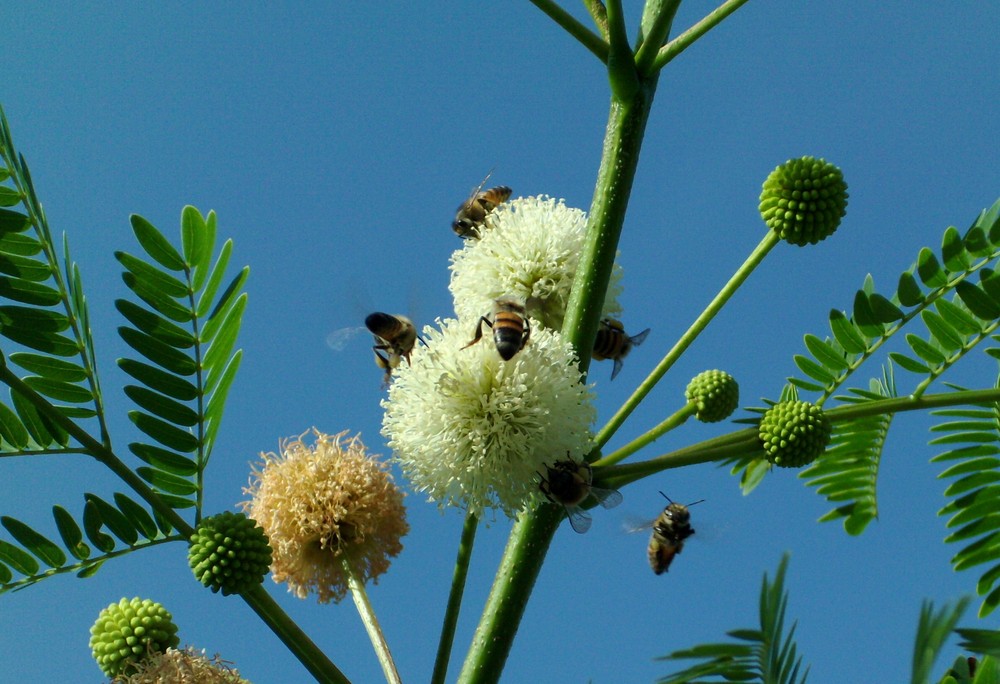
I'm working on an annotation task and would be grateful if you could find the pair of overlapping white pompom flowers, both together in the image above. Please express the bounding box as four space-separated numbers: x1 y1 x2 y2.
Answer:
382 197 621 517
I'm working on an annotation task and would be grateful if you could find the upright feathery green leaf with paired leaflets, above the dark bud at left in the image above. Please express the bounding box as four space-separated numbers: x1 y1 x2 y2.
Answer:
116 207 247 512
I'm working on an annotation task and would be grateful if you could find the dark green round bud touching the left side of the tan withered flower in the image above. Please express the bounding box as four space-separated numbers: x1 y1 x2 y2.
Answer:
188 511 271 596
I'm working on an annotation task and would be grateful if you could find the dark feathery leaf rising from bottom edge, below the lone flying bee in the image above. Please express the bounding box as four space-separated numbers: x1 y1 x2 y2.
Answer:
659 554 808 684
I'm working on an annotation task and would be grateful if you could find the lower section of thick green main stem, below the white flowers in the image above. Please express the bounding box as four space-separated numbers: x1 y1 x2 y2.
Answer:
458 505 565 684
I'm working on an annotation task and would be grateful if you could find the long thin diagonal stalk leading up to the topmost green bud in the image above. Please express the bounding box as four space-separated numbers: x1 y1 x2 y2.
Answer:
594 230 780 448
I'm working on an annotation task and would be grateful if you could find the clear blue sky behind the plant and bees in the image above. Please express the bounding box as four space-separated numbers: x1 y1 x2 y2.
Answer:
0 0 1000 684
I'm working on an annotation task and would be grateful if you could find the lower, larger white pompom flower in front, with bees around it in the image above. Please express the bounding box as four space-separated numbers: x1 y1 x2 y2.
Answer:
382 319 596 517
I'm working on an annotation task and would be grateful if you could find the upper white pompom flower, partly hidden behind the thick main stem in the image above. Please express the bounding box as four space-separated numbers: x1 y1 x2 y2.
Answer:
449 195 622 330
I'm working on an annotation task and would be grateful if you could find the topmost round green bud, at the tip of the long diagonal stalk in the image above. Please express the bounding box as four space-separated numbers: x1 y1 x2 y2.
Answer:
760 157 847 247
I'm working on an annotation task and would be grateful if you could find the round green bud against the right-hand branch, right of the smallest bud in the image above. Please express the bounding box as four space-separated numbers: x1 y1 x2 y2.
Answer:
757 401 833 468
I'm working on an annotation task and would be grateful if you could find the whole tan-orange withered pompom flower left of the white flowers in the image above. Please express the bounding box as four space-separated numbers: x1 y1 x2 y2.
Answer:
243 430 410 603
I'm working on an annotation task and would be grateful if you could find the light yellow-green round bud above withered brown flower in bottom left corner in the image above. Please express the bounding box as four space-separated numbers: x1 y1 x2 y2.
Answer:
90 597 180 677
